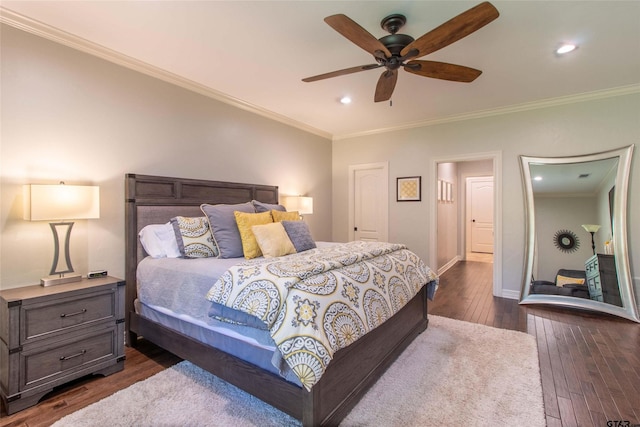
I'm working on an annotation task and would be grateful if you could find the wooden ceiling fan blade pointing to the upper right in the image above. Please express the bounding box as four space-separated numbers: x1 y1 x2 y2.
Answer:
400 2 500 58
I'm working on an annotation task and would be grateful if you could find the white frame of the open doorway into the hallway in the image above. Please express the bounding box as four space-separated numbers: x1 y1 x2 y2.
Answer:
427 151 504 298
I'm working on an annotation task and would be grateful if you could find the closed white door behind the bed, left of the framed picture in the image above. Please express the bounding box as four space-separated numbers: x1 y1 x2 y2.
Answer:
349 163 389 241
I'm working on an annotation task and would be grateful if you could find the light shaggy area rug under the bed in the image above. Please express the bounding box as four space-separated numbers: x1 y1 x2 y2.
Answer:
54 316 546 427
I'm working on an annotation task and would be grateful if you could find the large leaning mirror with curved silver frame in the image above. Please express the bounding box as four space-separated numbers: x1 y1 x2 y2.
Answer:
520 145 640 322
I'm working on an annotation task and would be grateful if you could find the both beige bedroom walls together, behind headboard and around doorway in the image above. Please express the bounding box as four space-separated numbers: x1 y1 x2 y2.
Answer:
0 22 640 310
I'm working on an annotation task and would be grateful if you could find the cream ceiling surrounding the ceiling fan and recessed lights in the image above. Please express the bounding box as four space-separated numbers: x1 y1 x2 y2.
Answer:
1 0 640 139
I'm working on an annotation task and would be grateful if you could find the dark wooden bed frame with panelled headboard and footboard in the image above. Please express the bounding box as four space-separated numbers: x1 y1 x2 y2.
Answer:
125 174 428 426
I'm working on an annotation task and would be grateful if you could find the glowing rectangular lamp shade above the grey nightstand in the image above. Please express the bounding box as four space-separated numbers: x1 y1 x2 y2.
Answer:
23 184 100 221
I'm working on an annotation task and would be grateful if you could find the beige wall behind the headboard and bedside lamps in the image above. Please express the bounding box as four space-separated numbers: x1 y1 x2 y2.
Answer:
0 26 331 289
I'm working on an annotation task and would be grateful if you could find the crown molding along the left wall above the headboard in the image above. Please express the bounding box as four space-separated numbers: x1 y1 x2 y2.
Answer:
0 6 332 140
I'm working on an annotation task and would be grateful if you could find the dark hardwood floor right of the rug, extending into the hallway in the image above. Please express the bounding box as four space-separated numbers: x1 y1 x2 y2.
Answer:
429 262 640 427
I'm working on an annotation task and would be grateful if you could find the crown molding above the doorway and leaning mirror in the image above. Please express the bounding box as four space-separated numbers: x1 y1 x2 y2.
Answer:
333 84 640 141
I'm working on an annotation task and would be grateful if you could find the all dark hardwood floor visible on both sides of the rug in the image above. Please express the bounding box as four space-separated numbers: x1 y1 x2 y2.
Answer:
0 262 640 427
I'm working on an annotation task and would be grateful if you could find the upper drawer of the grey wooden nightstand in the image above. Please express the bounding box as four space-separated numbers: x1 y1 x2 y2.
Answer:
20 287 116 345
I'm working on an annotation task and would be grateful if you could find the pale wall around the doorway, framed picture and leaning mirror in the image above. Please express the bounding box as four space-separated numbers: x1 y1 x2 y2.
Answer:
332 94 640 306
